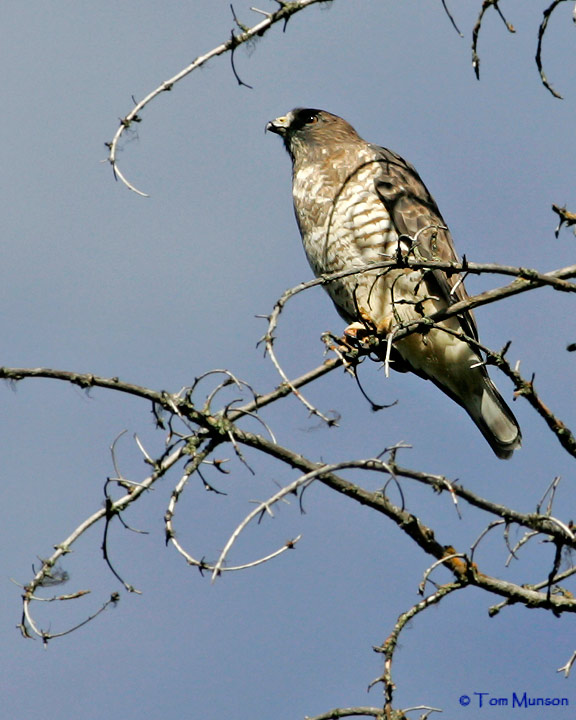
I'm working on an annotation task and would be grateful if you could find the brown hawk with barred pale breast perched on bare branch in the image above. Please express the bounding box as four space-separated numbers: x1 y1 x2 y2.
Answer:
266 108 522 459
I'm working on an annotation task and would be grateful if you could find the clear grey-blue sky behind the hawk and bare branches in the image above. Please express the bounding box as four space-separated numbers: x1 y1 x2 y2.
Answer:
0 0 576 720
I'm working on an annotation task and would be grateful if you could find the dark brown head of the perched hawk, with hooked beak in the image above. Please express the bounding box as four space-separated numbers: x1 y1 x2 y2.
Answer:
266 108 359 159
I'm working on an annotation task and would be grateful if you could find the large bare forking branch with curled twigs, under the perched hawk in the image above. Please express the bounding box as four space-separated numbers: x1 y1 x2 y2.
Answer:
6 253 576 718
